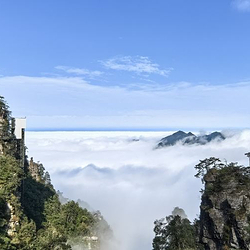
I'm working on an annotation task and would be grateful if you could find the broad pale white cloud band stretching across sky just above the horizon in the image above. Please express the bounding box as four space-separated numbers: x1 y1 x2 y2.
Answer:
0 76 250 129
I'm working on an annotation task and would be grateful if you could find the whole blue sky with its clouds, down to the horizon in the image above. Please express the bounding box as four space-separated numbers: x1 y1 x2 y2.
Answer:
0 0 250 129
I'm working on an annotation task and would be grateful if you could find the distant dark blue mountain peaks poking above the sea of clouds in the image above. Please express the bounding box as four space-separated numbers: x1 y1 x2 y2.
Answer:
157 131 226 148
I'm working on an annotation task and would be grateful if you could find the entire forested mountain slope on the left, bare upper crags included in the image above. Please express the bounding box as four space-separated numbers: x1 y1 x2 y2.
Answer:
0 97 112 250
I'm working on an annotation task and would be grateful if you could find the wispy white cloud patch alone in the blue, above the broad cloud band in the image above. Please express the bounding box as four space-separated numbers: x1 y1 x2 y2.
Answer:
102 56 173 77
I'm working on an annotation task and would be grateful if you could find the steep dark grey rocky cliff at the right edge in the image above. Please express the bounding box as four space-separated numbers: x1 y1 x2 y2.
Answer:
200 164 250 250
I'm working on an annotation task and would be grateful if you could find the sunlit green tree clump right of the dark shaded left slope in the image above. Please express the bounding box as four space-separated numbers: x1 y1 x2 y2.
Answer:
35 195 95 249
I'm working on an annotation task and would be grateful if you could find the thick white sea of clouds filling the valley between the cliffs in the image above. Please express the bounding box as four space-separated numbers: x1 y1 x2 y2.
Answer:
26 130 250 250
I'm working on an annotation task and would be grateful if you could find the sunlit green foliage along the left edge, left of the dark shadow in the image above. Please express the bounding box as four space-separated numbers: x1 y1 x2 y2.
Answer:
0 155 36 249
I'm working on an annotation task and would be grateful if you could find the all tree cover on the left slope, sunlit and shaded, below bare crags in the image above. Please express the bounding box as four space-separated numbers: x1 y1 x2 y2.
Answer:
0 155 104 250
